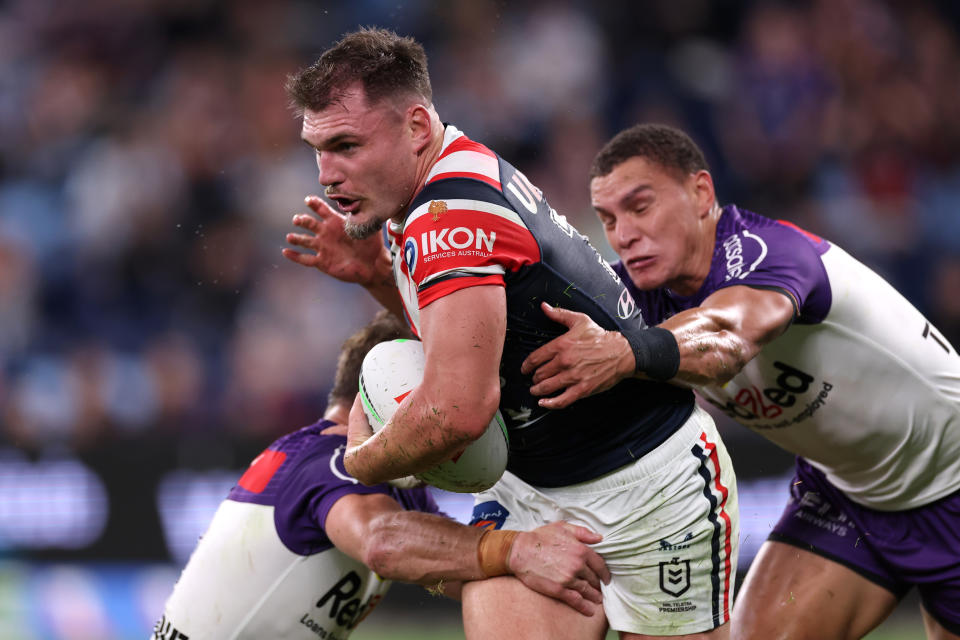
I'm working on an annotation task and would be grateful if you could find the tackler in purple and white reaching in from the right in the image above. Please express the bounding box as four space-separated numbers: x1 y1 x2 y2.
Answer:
524 125 960 640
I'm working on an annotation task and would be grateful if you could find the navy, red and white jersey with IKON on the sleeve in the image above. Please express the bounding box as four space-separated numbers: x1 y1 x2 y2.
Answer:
388 125 694 487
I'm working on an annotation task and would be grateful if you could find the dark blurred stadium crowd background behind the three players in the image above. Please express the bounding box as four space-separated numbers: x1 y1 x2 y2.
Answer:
0 0 960 640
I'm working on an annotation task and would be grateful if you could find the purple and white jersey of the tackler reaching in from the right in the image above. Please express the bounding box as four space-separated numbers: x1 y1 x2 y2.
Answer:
614 206 960 511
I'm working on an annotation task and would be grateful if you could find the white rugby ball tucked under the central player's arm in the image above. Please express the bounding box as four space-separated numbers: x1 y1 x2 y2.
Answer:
360 339 507 493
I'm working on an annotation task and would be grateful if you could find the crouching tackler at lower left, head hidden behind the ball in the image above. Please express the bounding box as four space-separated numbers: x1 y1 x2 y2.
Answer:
153 311 609 640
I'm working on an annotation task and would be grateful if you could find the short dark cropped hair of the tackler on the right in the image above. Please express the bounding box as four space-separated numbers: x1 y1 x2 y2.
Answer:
590 124 710 180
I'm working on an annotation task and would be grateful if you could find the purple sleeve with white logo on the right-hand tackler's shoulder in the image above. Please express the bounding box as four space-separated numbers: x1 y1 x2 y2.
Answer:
710 221 831 324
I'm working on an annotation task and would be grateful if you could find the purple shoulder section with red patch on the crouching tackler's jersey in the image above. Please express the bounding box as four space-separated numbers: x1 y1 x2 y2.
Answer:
228 420 439 555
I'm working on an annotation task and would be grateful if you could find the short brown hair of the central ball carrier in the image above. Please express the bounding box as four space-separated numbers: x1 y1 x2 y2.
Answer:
286 28 433 113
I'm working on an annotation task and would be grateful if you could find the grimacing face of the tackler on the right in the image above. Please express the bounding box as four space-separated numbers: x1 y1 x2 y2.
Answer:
590 156 714 295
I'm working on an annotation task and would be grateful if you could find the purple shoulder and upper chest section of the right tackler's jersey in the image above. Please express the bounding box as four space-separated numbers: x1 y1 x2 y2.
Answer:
613 205 831 325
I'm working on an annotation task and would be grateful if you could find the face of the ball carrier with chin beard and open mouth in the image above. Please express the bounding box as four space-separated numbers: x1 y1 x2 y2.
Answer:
301 88 417 238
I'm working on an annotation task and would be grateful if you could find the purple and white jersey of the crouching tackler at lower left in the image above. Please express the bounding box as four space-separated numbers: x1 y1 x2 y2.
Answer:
153 421 439 640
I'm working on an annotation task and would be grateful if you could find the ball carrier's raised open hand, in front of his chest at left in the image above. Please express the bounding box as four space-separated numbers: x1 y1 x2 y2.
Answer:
283 196 390 286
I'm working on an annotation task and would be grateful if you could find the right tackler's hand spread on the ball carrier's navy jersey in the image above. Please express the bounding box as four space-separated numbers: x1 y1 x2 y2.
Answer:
520 302 636 409
